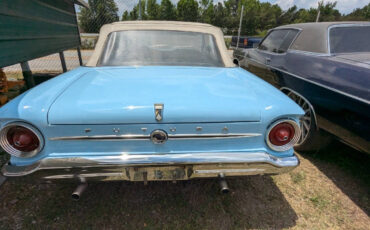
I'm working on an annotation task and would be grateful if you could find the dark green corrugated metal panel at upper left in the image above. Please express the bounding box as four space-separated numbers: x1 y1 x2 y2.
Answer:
0 0 80 67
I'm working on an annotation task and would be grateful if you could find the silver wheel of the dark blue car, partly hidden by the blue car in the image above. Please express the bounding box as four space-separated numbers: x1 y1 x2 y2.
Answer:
288 92 312 145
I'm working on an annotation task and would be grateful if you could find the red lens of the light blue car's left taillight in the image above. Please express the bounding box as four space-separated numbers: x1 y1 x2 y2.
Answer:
6 126 40 152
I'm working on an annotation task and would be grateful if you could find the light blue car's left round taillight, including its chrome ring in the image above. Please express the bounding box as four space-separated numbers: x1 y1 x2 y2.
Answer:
0 122 43 157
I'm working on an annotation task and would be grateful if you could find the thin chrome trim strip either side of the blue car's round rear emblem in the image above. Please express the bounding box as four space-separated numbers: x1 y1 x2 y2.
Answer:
49 133 262 141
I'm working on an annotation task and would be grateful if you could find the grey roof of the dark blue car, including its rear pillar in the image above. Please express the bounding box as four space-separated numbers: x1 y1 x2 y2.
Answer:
274 21 370 53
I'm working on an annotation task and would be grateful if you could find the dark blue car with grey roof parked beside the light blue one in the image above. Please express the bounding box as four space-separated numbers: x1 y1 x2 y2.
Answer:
239 22 370 153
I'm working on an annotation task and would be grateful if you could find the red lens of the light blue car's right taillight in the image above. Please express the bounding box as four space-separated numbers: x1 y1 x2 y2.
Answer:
268 122 295 146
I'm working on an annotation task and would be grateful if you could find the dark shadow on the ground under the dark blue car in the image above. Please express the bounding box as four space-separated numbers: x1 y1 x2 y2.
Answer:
302 141 370 216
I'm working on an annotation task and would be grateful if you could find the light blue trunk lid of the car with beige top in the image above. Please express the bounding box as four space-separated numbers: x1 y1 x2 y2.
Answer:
48 67 261 125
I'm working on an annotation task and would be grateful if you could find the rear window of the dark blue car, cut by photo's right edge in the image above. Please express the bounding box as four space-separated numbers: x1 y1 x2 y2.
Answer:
329 26 370 53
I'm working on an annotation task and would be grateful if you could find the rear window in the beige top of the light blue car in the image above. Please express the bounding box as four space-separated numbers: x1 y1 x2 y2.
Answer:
98 30 224 67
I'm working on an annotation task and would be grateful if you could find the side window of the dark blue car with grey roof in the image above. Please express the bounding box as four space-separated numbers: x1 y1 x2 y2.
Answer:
259 29 298 53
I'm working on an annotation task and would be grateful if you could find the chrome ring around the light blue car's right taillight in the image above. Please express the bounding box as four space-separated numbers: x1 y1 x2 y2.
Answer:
265 119 301 152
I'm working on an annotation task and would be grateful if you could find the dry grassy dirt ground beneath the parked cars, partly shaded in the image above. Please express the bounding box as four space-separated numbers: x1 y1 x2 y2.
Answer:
0 143 370 229
